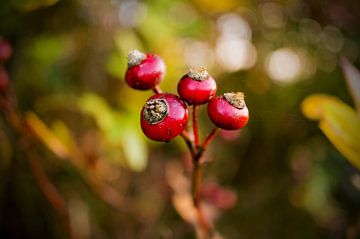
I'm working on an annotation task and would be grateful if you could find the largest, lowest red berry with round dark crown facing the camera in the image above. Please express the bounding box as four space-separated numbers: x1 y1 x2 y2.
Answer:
141 93 188 141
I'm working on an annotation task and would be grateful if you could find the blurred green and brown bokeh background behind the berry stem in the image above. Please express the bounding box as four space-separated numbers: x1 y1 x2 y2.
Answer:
0 0 360 239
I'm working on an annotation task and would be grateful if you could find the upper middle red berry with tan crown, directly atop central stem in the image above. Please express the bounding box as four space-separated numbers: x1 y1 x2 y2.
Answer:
178 67 217 105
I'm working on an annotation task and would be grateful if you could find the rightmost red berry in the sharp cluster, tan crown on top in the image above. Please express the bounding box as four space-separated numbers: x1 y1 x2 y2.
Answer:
207 92 249 130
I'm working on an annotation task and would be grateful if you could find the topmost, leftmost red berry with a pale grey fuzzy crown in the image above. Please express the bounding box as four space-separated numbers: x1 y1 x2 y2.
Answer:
125 50 165 90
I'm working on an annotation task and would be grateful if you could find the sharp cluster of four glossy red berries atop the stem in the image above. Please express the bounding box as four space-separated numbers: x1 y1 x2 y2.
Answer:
125 50 249 141
